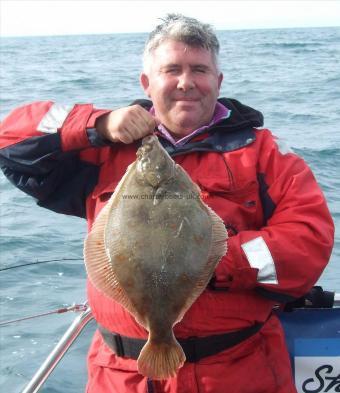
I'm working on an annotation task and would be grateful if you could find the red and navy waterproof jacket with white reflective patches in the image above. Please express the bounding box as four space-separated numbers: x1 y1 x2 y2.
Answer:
0 99 334 393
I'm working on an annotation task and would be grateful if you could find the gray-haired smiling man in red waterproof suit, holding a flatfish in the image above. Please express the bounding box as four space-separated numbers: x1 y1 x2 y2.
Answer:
0 15 334 393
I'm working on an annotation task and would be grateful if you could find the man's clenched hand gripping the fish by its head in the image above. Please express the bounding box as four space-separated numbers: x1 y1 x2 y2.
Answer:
96 105 159 144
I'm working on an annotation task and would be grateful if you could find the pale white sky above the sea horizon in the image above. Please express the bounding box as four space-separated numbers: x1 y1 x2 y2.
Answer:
0 0 340 37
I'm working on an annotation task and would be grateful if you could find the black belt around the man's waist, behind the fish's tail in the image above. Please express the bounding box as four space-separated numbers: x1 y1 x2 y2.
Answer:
98 323 263 363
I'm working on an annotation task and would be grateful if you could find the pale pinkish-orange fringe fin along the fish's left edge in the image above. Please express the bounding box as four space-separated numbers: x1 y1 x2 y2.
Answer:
84 165 136 314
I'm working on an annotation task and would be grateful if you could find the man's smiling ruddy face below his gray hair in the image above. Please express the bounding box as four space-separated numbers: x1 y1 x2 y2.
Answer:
141 40 223 136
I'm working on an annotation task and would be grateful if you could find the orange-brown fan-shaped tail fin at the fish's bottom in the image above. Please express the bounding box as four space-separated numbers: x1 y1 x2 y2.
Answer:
137 338 185 379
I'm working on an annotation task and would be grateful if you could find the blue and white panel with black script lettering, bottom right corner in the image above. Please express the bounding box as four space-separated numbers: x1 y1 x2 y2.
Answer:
279 308 340 393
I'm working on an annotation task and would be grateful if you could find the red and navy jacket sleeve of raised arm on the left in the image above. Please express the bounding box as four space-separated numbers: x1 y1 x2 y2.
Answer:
0 101 108 217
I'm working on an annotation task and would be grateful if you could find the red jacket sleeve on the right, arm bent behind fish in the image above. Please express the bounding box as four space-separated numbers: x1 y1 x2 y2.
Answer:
215 130 334 302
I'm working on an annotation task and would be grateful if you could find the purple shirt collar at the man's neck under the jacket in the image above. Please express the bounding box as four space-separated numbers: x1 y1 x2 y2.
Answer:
150 102 231 146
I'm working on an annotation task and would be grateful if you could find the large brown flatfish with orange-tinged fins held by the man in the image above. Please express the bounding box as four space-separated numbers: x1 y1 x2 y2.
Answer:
84 135 227 379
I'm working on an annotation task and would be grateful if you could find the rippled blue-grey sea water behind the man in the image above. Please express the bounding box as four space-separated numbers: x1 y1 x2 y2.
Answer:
0 27 340 393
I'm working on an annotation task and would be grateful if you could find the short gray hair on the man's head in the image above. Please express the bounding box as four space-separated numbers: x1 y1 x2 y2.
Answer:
143 14 220 70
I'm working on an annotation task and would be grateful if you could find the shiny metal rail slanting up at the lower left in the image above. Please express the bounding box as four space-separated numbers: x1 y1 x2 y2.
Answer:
22 306 93 393
